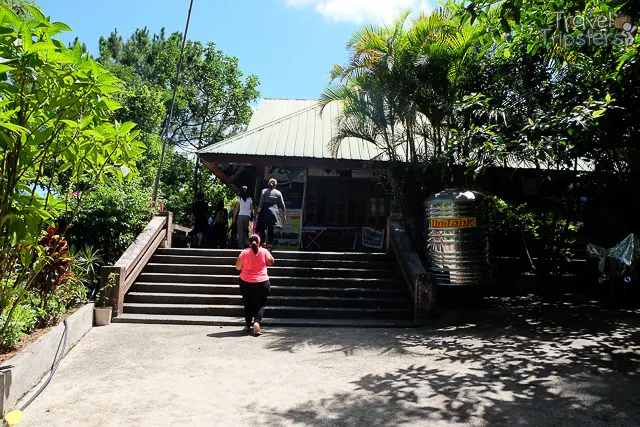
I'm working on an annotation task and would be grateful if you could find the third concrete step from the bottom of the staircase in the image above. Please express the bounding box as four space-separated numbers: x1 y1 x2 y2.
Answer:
125 292 408 308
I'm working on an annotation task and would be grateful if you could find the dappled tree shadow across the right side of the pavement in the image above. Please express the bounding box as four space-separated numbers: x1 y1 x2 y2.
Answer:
260 298 640 427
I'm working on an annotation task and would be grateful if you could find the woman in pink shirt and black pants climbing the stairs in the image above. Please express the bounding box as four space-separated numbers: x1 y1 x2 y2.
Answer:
236 234 275 335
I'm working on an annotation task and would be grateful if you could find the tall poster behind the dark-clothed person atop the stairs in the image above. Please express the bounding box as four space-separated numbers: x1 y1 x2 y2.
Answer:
258 166 307 251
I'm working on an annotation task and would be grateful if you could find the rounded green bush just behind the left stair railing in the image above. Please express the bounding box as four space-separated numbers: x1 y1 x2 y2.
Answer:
69 182 154 264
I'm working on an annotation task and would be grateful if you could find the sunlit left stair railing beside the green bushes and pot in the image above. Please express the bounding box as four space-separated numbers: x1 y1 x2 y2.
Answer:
101 212 173 317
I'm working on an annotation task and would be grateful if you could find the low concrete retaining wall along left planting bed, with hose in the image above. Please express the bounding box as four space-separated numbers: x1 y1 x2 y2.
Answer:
0 304 93 414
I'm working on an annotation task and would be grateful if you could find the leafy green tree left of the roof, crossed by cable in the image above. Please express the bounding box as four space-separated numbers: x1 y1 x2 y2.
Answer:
94 28 259 224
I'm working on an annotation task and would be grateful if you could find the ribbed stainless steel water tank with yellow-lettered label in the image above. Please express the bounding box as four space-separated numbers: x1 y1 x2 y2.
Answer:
425 189 490 286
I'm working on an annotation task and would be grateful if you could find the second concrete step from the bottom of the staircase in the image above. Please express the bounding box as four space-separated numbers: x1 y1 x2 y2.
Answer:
124 303 411 319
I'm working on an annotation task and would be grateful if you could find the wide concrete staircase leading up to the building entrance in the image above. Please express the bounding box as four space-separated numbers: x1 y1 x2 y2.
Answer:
114 248 411 326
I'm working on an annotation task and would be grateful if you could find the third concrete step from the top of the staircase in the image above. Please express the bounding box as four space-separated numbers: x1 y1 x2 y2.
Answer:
142 263 397 279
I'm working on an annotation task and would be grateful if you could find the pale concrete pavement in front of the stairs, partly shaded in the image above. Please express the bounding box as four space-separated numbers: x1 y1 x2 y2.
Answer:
17 301 640 427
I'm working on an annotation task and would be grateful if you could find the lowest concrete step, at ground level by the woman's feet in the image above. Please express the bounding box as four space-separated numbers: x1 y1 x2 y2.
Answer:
113 313 414 328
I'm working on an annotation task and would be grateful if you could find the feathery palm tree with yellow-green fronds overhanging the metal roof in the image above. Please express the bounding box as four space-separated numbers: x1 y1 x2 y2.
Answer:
321 9 485 162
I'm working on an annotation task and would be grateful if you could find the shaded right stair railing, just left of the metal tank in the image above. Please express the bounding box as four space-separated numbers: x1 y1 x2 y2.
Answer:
387 220 437 324
